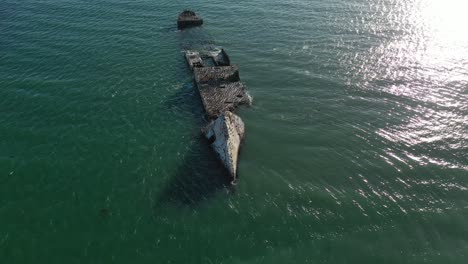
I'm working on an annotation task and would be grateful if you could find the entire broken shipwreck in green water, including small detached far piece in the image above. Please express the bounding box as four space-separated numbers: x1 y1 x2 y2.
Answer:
178 10 252 183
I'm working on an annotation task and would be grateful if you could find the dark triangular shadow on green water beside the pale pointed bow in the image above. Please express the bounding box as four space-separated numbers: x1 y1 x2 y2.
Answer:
155 135 233 207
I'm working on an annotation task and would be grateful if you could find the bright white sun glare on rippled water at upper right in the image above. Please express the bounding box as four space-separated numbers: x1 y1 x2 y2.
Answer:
345 0 468 170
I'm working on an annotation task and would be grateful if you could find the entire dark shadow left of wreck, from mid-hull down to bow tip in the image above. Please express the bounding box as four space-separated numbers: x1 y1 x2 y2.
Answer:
154 77 233 208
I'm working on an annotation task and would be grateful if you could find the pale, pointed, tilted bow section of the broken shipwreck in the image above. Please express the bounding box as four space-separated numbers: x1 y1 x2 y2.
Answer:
204 111 245 181
